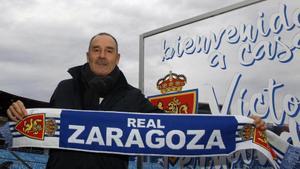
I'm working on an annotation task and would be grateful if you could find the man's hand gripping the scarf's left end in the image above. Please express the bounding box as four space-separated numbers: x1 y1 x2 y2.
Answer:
6 100 27 122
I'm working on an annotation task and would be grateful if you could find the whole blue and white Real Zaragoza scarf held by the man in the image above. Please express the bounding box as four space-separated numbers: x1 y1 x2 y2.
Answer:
10 109 295 168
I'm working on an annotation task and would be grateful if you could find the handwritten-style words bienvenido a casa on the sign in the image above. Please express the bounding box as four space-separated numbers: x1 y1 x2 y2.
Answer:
162 4 300 70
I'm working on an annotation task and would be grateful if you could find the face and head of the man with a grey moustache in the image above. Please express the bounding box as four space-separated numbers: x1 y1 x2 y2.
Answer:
87 35 120 77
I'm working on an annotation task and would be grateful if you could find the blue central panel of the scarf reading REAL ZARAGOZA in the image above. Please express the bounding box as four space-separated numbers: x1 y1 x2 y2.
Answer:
59 110 238 156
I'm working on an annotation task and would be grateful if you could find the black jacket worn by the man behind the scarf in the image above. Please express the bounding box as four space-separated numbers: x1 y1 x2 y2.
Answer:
47 66 161 169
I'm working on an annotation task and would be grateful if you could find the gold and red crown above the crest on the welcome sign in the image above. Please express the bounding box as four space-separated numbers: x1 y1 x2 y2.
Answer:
156 71 186 94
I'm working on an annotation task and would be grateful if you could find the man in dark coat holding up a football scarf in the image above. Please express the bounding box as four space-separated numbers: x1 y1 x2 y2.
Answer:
7 33 265 169
